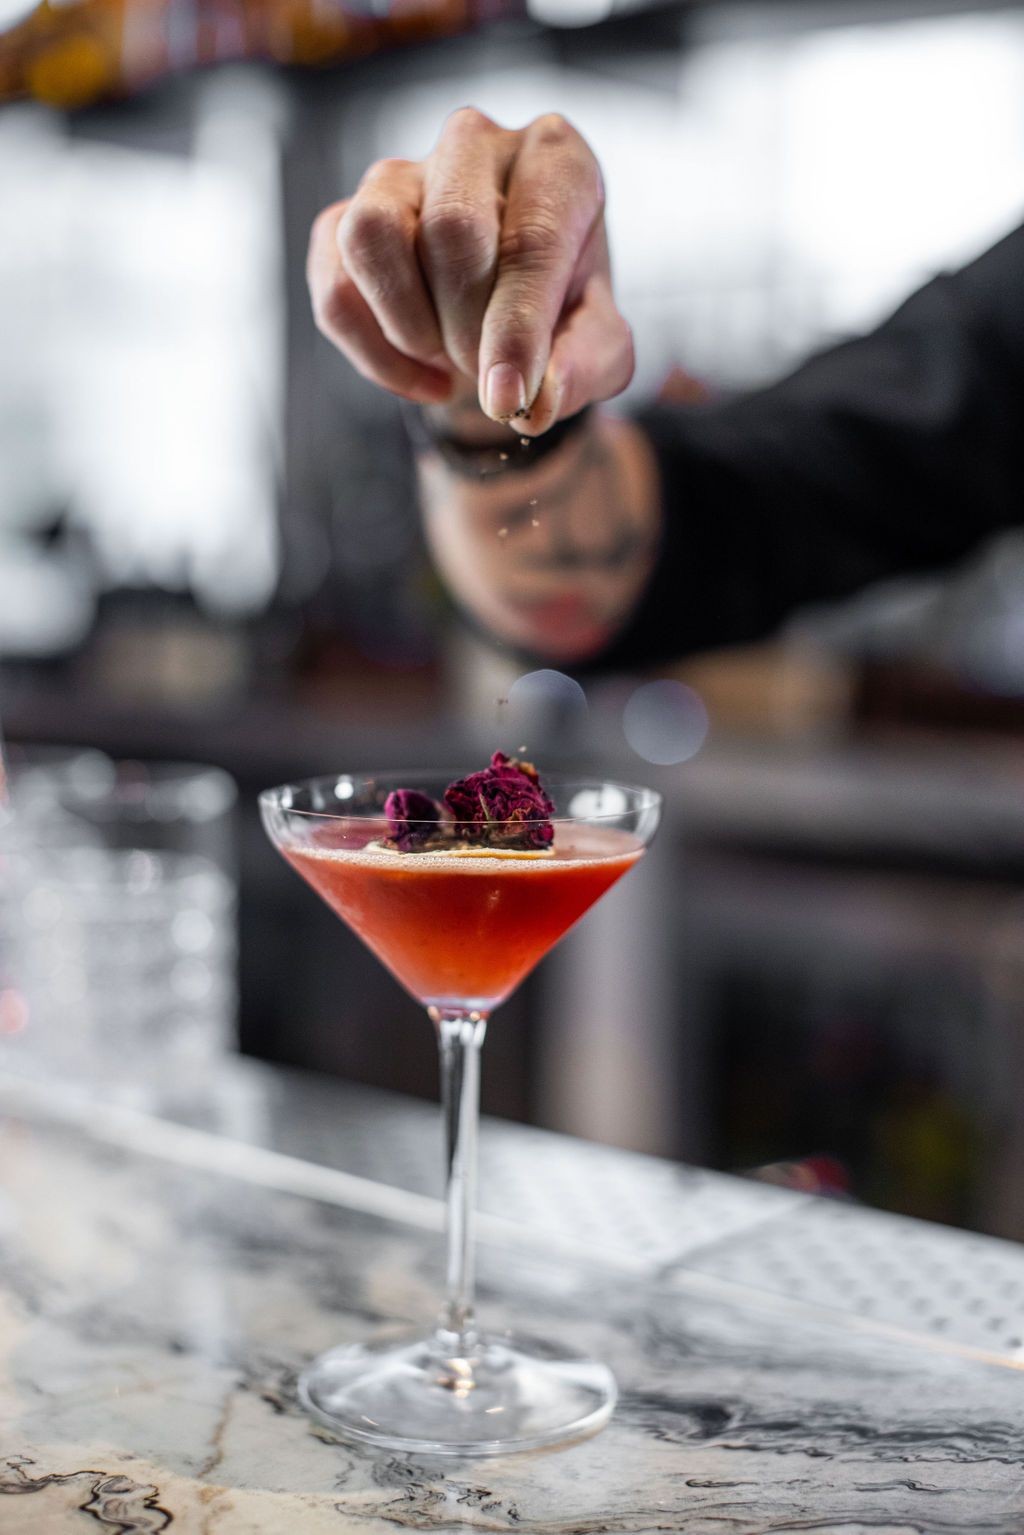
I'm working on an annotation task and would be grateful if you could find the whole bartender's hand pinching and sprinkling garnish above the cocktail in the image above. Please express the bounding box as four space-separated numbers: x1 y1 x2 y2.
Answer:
307 107 633 436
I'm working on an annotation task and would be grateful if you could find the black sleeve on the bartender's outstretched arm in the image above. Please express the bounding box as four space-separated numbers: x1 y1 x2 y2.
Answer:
597 227 1024 666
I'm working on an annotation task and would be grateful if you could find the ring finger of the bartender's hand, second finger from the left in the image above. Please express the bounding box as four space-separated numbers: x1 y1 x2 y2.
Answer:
338 160 444 365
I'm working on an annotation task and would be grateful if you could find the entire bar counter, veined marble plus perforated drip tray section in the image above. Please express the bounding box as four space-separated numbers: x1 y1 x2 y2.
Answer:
0 1065 1024 1535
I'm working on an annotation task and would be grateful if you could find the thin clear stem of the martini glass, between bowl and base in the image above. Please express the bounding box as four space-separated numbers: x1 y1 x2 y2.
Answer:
430 1007 487 1346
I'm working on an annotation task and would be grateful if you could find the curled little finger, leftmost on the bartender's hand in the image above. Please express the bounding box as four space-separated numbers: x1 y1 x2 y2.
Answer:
306 203 451 404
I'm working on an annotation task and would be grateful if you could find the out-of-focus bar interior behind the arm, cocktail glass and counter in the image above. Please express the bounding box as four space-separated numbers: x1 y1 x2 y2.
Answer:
0 0 1024 1237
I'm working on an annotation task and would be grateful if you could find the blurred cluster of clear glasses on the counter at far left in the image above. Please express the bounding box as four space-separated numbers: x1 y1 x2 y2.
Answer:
0 751 236 1107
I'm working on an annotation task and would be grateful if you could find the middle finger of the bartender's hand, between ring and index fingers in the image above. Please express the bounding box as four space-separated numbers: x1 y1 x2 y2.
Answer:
419 107 517 378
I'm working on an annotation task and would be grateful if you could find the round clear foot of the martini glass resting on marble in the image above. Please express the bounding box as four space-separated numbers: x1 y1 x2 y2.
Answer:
299 1332 617 1457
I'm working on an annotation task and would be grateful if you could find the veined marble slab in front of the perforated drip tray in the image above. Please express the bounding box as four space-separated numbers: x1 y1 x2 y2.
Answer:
0 1116 1024 1535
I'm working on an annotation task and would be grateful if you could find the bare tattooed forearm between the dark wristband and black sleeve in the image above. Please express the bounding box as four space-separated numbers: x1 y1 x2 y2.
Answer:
418 411 662 663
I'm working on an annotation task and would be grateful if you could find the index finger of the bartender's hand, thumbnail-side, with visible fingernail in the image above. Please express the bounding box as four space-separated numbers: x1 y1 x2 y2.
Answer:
477 115 603 421
